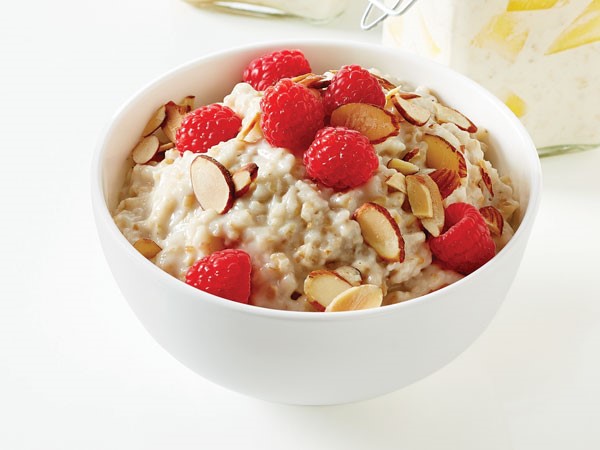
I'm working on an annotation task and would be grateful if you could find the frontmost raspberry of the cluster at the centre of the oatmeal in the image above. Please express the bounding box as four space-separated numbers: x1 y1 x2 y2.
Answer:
304 127 379 191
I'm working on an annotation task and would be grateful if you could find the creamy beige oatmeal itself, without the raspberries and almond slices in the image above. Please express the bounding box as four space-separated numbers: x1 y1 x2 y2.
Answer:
113 79 518 311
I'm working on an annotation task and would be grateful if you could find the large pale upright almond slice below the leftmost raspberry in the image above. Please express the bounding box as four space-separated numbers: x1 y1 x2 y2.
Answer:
190 155 235 214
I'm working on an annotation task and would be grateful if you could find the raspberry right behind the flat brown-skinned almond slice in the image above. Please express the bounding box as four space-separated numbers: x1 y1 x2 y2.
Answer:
323 65 385 114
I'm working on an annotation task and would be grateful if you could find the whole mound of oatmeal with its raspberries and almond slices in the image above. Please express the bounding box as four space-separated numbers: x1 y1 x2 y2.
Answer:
113 50 519 312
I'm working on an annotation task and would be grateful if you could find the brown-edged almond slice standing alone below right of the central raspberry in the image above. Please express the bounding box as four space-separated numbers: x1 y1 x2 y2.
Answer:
352 202 404 262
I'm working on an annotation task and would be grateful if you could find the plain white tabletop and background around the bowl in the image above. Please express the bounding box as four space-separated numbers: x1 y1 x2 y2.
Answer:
0 0 600 450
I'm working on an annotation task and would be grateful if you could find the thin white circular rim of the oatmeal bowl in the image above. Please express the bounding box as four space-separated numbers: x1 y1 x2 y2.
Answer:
91 39 542 321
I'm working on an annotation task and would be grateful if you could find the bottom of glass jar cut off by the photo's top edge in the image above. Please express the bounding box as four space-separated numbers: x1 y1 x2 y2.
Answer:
185 0 348 22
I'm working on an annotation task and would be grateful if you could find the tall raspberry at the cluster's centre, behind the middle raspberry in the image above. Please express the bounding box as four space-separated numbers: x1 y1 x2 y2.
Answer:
260 78 325 151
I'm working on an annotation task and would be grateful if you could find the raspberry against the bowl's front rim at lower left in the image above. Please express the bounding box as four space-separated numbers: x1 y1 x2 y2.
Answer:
185 249 252 303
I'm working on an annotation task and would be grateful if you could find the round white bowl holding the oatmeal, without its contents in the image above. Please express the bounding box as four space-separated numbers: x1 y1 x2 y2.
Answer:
92 41 541 405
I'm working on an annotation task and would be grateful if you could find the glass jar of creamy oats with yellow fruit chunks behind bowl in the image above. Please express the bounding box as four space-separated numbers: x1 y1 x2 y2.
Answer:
383 0 600 154
